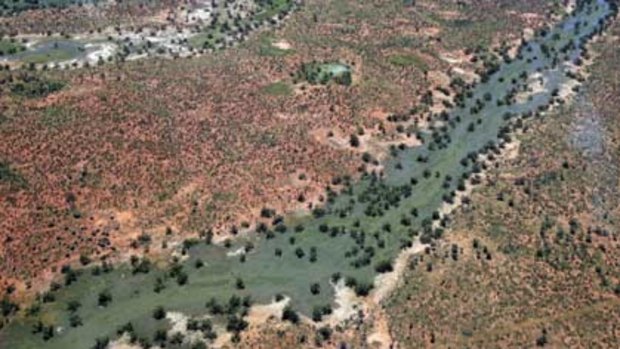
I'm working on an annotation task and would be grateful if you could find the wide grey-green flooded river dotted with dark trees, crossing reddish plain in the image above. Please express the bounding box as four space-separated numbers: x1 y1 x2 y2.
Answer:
0 0 612 349
